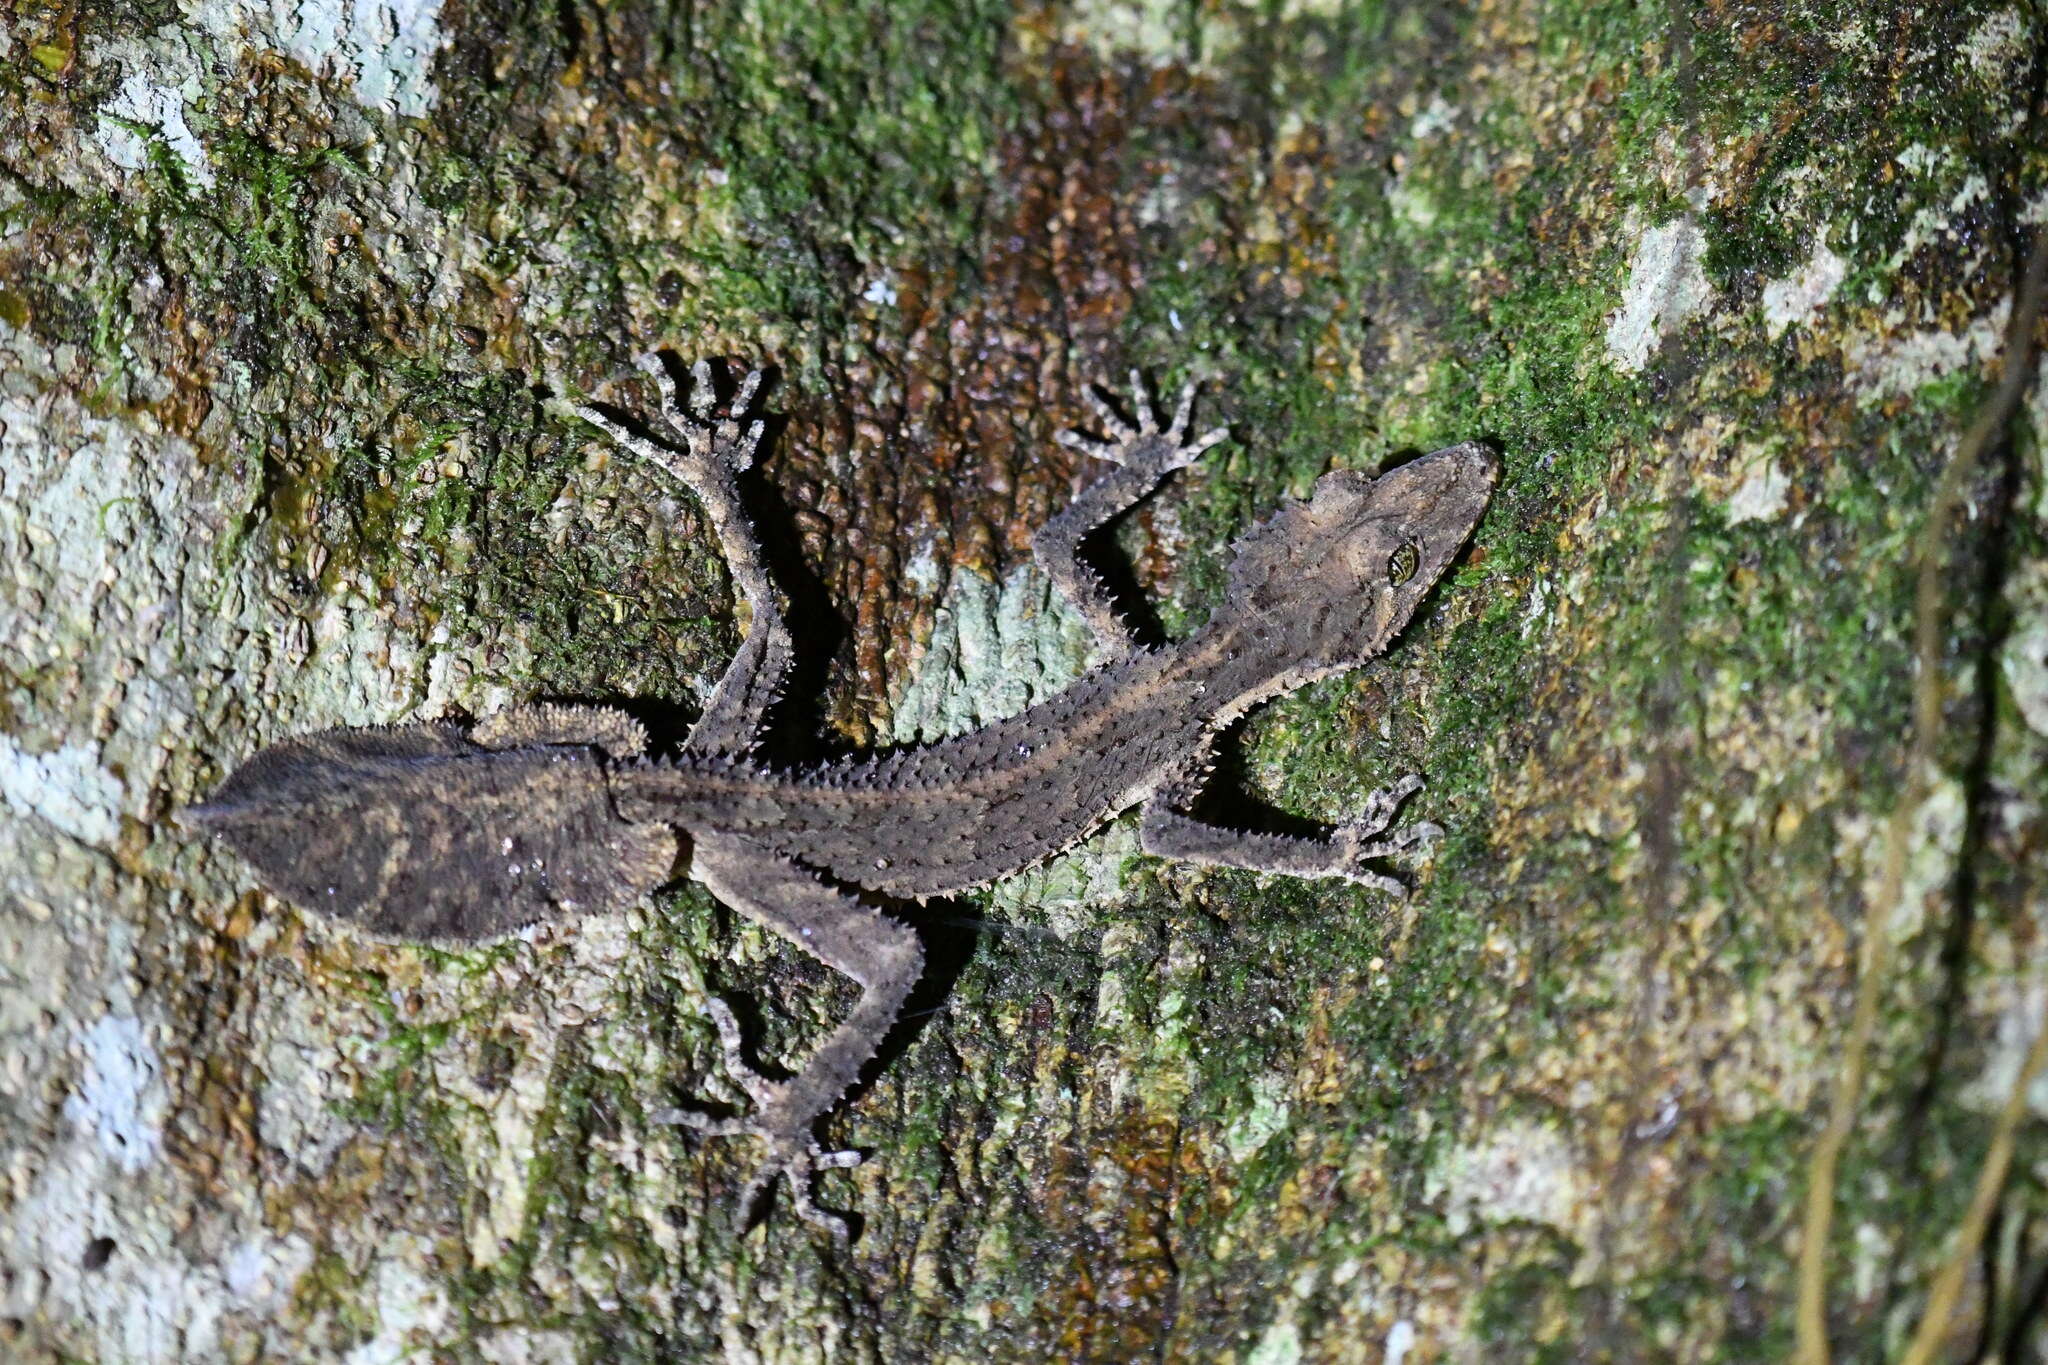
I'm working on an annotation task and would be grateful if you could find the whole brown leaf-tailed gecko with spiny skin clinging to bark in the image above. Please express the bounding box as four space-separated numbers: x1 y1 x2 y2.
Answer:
182 356 1495 1238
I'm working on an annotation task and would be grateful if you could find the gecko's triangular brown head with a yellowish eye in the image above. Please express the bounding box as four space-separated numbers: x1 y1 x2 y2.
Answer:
1225 442 1497 667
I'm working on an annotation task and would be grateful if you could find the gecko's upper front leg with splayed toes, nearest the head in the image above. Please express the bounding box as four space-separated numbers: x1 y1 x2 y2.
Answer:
1030 370 1229 659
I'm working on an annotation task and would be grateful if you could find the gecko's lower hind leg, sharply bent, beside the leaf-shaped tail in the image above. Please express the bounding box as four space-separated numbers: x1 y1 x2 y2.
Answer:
659 835 924 1238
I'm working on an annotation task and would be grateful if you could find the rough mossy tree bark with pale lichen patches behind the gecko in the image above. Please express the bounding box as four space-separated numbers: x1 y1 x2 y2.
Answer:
0 0 2048 1365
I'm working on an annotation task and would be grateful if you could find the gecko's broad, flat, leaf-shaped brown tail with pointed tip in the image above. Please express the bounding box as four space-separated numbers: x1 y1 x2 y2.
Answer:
178 724 676 939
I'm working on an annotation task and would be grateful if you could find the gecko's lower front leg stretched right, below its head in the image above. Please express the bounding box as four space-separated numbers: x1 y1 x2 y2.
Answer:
1139 774 1444 898
